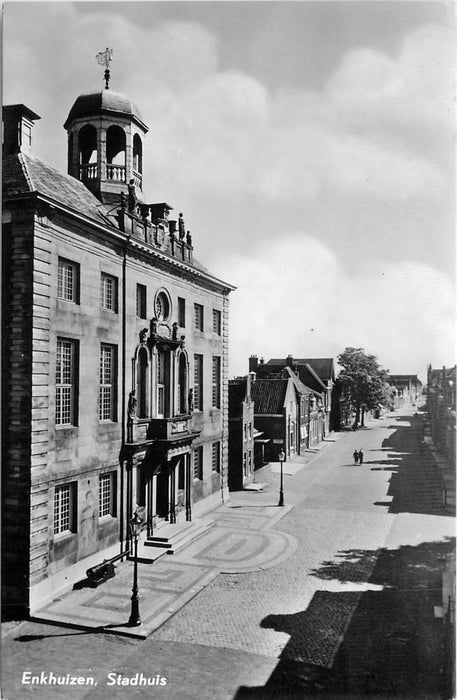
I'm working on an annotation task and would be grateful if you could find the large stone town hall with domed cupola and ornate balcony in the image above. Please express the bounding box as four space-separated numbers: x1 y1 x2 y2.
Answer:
2 88 234 615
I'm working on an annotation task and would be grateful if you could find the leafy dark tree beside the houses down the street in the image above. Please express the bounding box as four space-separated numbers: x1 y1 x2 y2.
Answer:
338 347 390 428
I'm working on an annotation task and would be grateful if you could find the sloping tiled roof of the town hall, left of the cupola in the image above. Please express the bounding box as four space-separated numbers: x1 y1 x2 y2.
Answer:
3 153 107 224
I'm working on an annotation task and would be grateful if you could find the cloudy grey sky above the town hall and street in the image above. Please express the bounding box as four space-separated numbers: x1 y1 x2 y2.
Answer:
3 0 456 381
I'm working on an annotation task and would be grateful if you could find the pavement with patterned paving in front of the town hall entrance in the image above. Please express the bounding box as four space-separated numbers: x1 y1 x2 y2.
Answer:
31 436 339 639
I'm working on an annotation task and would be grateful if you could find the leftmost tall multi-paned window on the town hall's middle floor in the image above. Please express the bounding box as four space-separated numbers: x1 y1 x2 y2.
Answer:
56 338 77 425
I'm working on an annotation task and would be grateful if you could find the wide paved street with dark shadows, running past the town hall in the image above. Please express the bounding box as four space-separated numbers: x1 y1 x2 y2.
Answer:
3 410 454 700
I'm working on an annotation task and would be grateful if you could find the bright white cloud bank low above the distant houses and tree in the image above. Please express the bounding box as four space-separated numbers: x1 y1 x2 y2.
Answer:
224 232 455 376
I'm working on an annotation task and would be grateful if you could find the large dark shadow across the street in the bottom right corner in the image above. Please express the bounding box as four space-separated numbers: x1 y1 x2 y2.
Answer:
235 538 455 700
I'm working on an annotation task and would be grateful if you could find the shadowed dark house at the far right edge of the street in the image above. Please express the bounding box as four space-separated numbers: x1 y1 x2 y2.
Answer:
427 365 456 463
